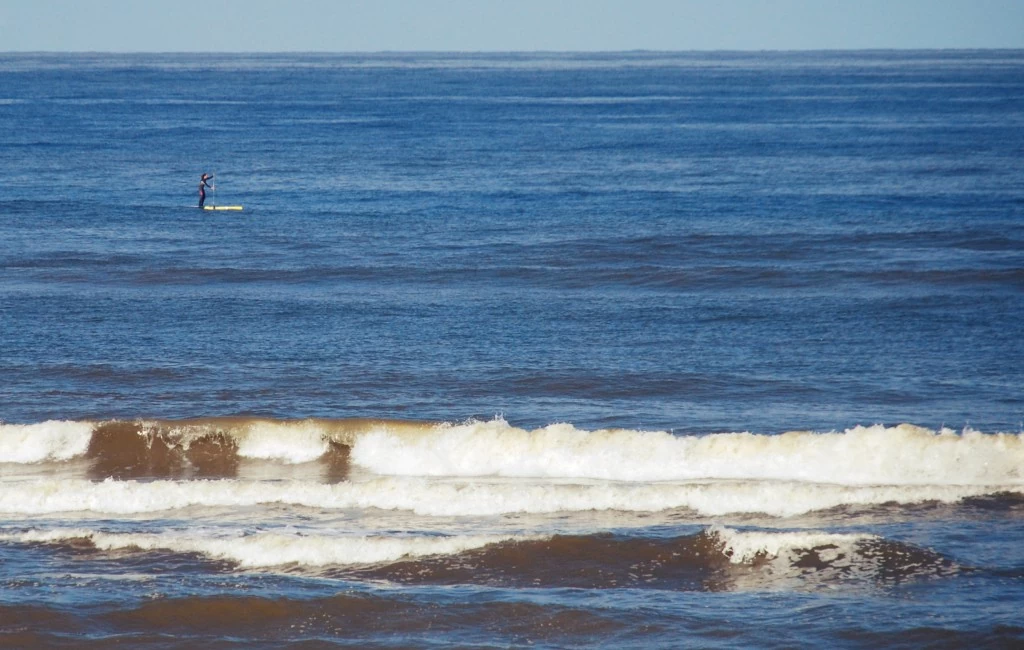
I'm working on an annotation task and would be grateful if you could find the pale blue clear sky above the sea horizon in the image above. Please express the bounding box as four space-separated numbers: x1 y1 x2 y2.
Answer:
0 0 1024 52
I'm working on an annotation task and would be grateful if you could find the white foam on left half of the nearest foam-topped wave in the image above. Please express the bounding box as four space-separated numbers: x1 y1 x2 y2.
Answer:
8 528 525 568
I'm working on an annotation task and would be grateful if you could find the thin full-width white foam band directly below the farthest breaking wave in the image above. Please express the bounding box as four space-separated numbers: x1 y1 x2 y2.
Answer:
0 477 1024 517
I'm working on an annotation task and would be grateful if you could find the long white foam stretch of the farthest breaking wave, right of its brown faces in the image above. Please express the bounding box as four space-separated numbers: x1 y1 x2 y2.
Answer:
351 420 1024 485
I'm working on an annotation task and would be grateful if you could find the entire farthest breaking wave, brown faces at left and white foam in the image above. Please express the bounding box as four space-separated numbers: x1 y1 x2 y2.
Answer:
0 419 1024 486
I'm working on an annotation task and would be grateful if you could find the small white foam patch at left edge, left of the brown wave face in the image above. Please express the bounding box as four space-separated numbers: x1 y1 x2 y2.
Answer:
0 420 93 463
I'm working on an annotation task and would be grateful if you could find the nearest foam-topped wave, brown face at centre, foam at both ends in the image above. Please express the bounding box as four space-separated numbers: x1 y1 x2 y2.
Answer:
0 526 958 590
